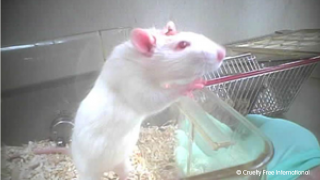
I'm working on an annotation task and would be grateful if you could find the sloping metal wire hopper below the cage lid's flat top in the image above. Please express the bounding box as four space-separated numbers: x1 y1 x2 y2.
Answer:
205 54 317 115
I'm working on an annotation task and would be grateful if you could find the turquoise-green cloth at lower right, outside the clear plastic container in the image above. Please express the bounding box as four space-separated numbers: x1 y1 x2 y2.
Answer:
247 114 320 180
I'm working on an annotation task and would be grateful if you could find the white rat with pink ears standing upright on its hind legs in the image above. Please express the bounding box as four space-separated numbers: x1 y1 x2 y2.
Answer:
33 22 225 180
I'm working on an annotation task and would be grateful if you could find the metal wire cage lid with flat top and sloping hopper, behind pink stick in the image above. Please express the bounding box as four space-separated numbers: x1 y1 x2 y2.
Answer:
205 29 320 115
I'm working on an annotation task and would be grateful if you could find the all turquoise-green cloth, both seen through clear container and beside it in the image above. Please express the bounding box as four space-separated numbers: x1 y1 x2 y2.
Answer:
175 114 320 180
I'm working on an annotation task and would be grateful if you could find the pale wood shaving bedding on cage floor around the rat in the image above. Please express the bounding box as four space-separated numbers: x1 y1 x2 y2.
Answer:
1 125 177 180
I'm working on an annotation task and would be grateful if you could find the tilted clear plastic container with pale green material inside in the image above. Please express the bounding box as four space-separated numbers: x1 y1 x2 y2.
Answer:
173 89 273 180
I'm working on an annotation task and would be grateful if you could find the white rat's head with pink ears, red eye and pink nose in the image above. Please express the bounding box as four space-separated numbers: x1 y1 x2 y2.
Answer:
127 22 225 81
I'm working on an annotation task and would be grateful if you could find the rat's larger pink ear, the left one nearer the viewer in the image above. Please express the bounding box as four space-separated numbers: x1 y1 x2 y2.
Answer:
131 28 156 56
